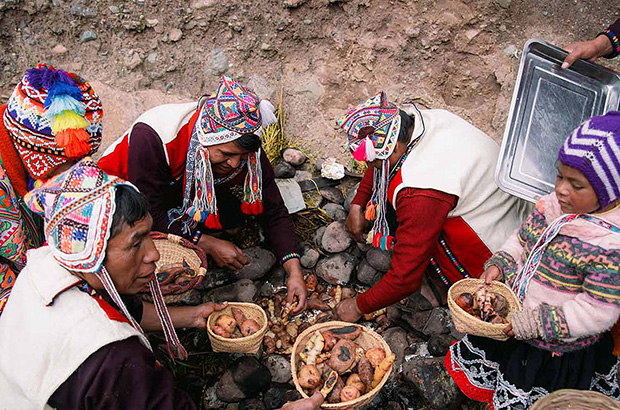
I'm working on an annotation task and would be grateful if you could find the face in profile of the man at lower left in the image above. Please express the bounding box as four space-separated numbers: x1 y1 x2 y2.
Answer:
103 214 159 295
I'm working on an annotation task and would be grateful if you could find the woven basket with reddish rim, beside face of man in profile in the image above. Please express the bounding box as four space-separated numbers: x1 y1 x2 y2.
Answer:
142 232 207 304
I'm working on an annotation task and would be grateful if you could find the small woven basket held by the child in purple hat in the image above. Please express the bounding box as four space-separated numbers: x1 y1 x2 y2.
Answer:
448 278 521 340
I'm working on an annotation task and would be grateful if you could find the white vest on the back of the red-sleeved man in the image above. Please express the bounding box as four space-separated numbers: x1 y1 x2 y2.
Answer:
392 105 531 252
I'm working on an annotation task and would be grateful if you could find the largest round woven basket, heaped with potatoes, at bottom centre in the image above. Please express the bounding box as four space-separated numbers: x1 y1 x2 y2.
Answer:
291 321 392 409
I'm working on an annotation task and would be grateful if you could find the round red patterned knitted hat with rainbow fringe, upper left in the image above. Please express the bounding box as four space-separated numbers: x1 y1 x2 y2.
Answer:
3 64 103 179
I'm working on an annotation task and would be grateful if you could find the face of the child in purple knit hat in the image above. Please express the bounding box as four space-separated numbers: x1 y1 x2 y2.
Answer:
555 162 600 214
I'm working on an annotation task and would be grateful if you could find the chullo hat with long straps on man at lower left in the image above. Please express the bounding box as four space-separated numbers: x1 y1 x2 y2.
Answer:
24 157 186 358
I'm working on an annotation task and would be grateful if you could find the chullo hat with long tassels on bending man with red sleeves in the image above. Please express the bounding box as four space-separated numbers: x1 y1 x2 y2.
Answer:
336 91 400 250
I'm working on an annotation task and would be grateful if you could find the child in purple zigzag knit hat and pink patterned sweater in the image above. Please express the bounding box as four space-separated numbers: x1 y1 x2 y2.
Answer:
445 111 620 410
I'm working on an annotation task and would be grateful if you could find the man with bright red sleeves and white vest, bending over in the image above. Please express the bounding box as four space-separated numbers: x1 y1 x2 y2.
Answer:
336 92 528 321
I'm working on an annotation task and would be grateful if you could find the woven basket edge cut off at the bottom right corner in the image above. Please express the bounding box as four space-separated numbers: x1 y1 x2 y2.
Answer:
530 389 620 410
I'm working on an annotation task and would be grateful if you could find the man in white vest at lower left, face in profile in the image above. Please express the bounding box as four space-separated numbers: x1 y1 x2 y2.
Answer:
0 158 322 410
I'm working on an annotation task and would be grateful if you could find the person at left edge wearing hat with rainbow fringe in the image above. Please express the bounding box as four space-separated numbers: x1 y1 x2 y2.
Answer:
0 65 103 313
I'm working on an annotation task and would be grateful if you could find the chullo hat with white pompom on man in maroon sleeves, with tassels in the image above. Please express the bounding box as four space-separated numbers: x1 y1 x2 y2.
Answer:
169 76 276 229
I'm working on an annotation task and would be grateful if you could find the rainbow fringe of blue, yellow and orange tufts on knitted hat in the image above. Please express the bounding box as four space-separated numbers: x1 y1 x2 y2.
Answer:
26 64 91 158
